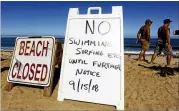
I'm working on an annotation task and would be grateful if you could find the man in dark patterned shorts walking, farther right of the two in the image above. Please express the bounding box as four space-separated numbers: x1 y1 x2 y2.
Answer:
150 19 172 67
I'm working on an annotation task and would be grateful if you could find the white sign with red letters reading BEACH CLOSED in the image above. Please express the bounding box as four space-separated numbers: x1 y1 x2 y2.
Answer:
7 36 55 86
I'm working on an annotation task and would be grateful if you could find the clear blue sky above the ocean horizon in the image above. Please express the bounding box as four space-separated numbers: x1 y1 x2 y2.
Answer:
1 1 179 37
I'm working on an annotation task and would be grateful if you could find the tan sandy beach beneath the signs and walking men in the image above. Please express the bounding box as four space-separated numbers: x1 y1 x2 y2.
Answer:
1 52 179 111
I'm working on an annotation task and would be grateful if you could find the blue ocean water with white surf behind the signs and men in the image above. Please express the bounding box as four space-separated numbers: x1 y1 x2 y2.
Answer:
1 35 179 54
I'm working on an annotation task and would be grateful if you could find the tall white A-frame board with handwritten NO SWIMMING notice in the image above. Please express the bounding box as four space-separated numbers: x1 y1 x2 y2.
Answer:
57 6 124 110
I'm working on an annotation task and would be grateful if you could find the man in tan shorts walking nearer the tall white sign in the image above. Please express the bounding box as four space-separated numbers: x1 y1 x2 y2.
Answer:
136 19 152 61
